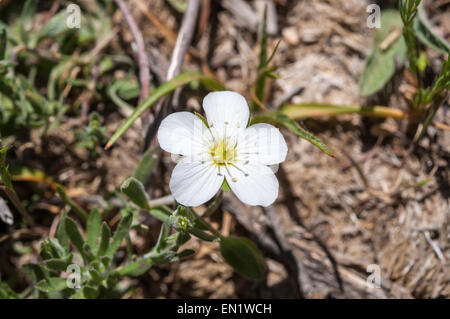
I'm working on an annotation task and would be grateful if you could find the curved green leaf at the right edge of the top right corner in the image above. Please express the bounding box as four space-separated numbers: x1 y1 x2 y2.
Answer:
413 3 450 54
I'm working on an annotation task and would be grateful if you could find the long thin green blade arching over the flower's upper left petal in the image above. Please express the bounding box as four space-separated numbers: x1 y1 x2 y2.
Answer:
105 72 223 149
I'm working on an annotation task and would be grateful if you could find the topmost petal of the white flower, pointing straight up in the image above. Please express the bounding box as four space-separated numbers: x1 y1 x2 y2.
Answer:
203 91 250 137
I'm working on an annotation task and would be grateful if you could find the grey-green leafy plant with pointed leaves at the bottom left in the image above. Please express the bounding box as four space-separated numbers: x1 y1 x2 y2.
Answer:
18 209 188 299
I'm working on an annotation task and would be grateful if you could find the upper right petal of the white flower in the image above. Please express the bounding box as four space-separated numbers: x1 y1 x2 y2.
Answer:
237 123 288 165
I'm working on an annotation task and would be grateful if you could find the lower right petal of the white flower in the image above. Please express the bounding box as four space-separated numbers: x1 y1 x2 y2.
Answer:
225 164 278 207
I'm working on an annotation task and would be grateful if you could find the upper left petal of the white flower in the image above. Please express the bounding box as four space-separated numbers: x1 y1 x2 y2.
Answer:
158 112 210 158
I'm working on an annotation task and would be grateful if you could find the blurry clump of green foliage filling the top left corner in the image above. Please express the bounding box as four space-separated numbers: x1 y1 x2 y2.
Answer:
0 0 114 136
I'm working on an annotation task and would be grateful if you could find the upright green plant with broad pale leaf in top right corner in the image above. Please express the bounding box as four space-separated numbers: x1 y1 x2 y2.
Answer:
354 0 450 139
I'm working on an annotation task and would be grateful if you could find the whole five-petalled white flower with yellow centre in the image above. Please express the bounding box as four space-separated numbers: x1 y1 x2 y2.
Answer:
158 91 287 207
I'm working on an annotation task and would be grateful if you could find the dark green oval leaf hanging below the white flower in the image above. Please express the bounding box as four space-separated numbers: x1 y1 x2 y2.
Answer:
220 237 266 280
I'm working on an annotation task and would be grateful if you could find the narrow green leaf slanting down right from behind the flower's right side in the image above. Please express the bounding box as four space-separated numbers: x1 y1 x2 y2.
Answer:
252 112 334 157
